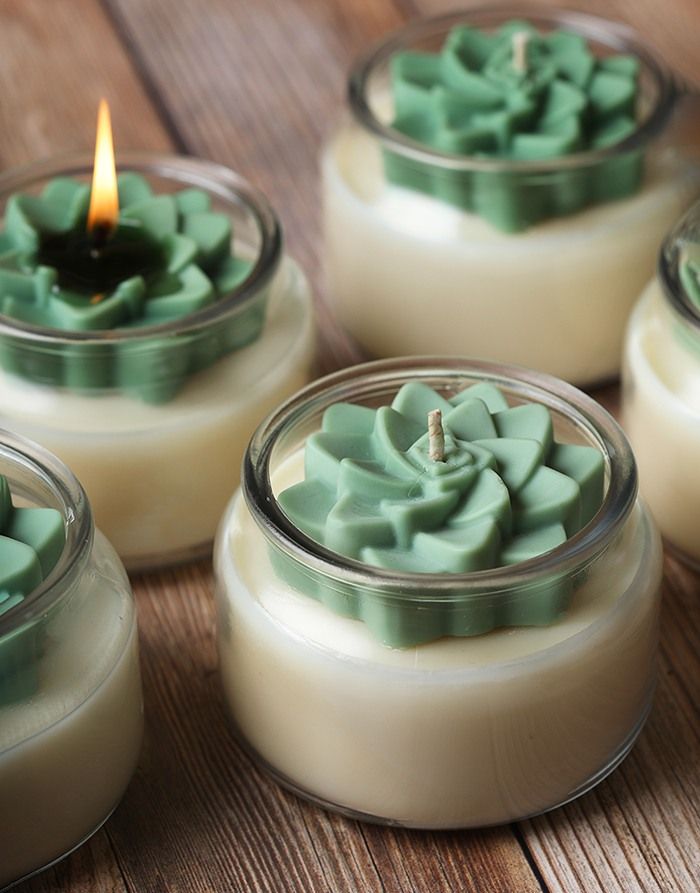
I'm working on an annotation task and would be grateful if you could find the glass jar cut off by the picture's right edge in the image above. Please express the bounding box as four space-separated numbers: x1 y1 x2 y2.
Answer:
622 205 700 564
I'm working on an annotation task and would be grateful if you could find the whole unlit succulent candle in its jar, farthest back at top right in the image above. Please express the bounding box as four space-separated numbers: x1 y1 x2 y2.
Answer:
322 10 698 384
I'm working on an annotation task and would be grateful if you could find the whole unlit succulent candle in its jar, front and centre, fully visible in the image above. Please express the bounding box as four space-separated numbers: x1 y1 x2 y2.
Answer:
215 360 661 828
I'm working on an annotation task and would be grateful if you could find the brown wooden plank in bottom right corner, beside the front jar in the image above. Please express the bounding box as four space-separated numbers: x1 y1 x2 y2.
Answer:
524 559 700 893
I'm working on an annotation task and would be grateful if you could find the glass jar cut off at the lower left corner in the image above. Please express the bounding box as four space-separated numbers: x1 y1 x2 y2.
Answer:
0 431 143 888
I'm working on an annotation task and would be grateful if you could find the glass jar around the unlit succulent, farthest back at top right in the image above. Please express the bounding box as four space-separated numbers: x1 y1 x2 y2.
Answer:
322 6 698 385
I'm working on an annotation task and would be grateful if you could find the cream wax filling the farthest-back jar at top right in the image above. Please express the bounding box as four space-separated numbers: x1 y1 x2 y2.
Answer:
323 125 692 384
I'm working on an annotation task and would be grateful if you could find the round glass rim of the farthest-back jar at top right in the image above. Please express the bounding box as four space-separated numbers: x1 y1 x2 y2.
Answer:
347 5 679 175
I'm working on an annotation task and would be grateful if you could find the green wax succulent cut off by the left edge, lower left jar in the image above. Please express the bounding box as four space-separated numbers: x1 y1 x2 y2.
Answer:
0 475 65 706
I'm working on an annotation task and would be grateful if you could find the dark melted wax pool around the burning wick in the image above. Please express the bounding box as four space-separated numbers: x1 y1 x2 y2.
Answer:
37 220 166 298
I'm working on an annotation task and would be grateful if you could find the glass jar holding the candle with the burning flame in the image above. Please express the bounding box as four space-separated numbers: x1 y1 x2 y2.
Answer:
0 153 313 569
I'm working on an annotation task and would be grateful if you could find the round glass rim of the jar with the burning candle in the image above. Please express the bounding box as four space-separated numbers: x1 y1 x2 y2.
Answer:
0 150 283 347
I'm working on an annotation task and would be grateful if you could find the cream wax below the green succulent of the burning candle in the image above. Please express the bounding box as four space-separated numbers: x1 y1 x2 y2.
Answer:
0 261 313 568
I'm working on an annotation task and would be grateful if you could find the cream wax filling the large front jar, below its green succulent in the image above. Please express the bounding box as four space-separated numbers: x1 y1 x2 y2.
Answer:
216 459 661 828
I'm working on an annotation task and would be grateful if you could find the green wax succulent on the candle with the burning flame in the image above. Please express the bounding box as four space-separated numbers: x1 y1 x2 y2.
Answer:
0 172 265 403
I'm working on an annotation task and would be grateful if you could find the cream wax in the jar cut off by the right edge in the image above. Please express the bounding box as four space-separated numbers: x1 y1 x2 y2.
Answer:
623 280 700 561
